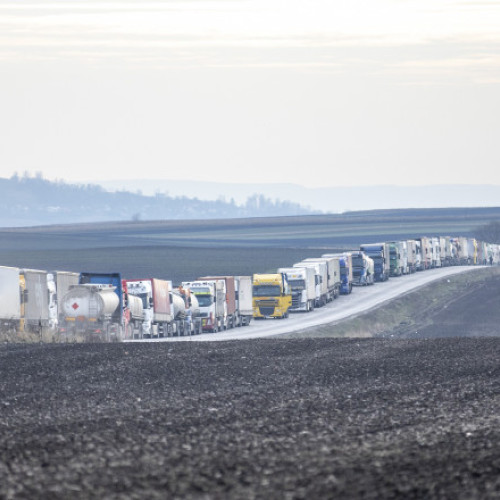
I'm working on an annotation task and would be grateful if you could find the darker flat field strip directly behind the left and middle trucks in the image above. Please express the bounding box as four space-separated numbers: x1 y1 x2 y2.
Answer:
0 246 334 284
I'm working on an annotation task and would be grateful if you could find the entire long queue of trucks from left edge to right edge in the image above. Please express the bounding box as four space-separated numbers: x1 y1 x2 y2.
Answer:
0 237 500 340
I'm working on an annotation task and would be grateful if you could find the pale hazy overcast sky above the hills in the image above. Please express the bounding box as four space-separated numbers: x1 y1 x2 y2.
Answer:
0 0 500 187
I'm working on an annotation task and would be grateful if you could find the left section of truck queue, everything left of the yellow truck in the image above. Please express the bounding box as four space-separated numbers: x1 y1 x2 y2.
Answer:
0 266 252 340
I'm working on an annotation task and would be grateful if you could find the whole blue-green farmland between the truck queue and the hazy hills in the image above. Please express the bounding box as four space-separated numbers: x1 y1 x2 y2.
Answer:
0 208 500 283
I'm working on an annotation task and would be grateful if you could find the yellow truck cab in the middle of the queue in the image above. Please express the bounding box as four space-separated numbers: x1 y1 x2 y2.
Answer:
253 273 292 319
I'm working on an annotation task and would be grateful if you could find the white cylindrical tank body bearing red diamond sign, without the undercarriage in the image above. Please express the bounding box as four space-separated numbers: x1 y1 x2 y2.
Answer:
61 284 120 319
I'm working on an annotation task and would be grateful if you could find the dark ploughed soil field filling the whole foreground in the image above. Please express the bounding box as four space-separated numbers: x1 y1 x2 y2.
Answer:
0 338 500 499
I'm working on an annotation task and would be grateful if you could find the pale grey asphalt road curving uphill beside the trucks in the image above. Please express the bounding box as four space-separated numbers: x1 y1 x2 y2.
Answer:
127 266 482 342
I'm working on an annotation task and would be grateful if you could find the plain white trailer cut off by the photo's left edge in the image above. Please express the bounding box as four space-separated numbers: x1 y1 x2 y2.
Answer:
0 266 21 332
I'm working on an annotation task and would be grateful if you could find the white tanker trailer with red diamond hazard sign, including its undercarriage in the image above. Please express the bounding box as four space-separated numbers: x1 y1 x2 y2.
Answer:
60 283 121 341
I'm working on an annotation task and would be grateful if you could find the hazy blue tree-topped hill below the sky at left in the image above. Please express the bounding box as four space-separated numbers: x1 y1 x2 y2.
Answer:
0 176 318 227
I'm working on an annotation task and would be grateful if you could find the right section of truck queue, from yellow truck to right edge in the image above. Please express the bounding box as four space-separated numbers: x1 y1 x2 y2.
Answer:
253 237 500 318
